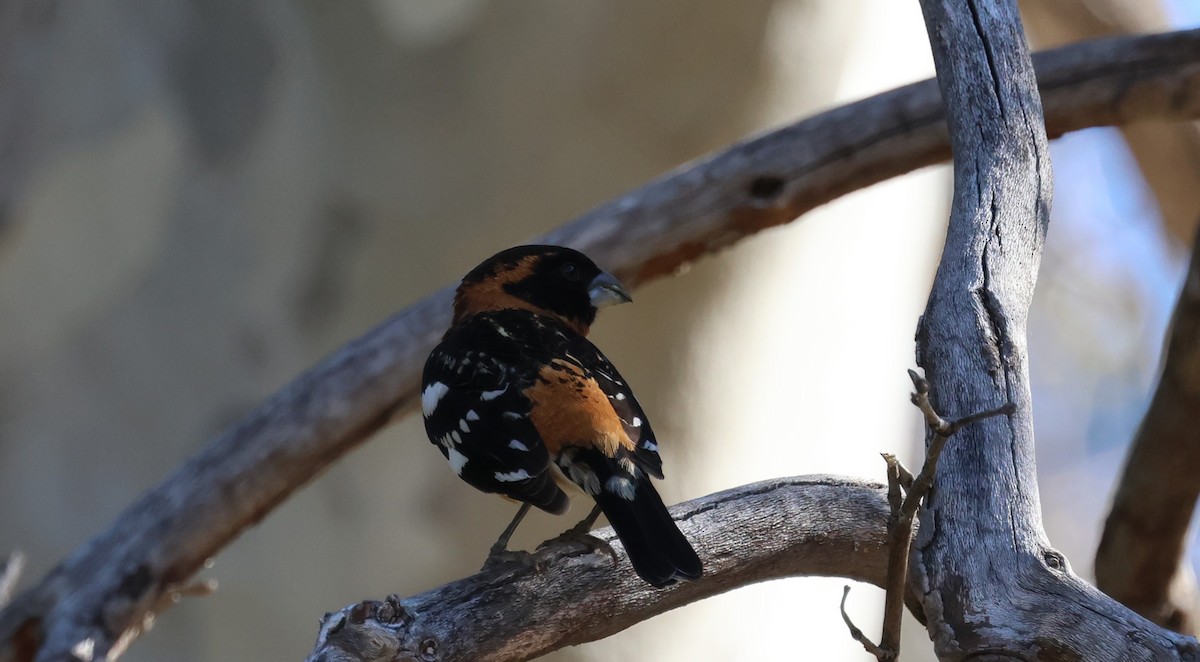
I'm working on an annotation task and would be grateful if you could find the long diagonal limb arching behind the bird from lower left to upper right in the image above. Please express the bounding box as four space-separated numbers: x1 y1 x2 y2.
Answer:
0 31 1200 661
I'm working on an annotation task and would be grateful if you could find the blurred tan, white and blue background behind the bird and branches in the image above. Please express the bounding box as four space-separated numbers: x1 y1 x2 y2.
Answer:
0 0 1200 662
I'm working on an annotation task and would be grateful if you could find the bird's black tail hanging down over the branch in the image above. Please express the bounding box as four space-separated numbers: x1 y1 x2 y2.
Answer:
595 474 703 588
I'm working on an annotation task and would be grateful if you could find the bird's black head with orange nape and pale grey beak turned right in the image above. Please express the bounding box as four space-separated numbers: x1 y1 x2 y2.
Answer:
455 246 631 333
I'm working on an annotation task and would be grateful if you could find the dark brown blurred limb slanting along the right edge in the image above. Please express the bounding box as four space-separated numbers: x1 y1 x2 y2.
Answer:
1096 233 1200 633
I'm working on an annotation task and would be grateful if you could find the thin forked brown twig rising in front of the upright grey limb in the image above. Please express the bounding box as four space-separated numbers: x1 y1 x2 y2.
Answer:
864 371 1016 662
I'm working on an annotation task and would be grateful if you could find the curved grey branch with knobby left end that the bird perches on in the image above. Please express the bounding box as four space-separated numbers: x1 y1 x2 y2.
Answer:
308 476 888 662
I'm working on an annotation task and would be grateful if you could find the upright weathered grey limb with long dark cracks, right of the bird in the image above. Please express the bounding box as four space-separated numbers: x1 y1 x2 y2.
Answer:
913 0 1200 660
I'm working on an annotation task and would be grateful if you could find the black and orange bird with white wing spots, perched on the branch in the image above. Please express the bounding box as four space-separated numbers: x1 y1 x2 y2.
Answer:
421 245 702 588
